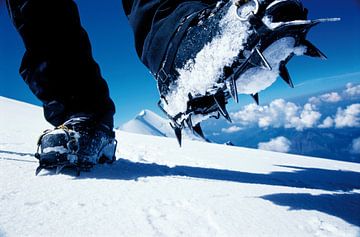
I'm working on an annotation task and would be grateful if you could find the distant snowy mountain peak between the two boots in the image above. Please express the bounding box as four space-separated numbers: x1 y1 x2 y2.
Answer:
120 110 204 141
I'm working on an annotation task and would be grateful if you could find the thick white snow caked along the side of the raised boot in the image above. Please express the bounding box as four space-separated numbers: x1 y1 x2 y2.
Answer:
164 0 250 116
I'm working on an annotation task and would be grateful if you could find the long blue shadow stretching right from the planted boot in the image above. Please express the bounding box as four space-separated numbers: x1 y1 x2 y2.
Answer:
79 159 360 191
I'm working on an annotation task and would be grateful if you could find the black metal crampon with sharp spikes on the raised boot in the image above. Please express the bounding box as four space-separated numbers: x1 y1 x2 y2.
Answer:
158 0 340 146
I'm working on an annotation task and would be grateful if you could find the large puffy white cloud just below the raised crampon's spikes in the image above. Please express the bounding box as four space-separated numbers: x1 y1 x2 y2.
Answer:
232 99 321 131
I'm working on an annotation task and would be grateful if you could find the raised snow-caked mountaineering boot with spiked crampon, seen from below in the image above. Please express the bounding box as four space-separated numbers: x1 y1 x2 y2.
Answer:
156 0 339 144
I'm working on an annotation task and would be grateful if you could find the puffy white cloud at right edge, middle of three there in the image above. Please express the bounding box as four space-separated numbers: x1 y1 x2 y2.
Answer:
334 104 360 128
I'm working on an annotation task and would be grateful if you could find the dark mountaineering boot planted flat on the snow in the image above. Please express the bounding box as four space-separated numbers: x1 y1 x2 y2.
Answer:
35 116 117 175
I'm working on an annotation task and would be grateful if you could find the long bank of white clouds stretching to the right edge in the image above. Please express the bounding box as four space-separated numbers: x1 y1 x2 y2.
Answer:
231 83 360 133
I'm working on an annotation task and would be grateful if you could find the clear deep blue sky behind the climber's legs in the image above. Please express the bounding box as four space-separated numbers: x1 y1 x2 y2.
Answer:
0 0 360 124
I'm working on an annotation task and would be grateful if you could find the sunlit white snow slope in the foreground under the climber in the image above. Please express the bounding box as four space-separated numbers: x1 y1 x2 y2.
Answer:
0 97 360 237
